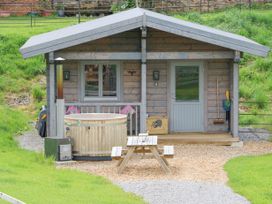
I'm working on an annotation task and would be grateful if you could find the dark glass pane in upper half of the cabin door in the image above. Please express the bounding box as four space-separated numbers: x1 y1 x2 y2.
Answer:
176 66 199 101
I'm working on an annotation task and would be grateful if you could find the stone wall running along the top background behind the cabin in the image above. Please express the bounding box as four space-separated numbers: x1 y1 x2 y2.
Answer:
0 0 272 16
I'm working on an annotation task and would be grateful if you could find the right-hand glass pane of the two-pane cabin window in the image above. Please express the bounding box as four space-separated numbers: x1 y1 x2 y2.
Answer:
103 65 117 96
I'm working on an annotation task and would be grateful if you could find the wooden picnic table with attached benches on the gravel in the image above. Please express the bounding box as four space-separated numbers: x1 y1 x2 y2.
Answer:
111 134 174 173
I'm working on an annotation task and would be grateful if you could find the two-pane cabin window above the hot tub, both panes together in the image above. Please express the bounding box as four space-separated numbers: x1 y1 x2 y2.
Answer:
83 63 119 99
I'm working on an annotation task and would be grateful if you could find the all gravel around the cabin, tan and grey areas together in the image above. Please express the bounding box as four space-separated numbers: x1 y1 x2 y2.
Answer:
16 130 272 204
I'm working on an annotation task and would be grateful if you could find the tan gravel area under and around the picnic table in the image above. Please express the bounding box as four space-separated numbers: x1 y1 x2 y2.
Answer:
69 141 272 183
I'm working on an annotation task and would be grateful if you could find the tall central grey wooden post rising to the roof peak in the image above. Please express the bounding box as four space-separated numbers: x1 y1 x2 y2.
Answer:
140 20 147 132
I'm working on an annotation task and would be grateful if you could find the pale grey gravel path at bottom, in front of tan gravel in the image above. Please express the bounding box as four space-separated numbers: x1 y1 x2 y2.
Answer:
117 180 250 204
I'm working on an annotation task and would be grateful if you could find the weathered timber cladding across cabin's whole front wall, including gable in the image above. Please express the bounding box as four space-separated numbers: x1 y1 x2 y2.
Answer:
62 29 232 132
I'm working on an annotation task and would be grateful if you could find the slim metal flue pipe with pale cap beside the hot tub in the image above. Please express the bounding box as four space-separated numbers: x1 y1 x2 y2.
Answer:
55 57 65 138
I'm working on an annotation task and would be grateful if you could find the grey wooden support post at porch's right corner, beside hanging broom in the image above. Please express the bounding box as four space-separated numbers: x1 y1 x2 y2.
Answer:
232 51 240 137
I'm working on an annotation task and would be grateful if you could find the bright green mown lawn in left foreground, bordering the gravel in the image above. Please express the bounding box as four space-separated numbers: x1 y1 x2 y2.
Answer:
0 106 143 204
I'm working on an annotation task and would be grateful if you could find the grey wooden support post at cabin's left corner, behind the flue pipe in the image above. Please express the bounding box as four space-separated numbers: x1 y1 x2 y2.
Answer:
47 52 57 137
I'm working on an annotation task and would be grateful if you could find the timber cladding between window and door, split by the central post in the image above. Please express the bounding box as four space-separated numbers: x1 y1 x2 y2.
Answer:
123 61 168 115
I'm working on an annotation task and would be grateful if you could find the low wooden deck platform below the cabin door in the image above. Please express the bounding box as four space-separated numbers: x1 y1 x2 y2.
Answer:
158 132 239 146
